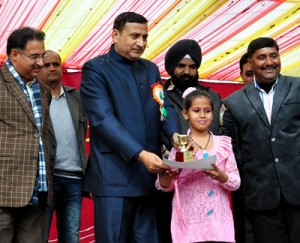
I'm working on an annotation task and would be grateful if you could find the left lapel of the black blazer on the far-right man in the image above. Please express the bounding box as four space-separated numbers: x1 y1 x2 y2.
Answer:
245 83 270 127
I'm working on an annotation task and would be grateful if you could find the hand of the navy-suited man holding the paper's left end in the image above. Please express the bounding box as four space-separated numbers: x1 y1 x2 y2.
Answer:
137 150 171 173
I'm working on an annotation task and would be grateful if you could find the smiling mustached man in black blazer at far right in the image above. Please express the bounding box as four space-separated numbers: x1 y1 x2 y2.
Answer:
222 37 300 243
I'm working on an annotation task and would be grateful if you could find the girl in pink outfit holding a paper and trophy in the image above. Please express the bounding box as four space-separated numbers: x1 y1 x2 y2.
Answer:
156 88 240 243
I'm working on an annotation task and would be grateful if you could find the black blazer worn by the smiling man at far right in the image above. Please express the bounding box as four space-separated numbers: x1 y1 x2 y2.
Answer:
221 75 300 210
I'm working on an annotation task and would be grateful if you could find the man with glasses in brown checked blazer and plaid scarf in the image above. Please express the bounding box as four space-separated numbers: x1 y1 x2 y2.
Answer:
0 27 52 243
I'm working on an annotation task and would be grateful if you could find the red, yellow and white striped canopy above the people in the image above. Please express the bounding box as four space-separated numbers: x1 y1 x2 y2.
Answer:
0 0 300 81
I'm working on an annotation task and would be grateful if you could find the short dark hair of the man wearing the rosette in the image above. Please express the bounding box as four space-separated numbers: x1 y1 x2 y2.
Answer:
113 12 148 32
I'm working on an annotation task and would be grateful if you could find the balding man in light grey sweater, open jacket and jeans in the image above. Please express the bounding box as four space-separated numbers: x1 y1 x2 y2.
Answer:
40 50 87 243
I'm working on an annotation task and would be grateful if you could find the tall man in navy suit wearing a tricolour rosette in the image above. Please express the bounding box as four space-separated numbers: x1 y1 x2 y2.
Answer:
81 12 179 243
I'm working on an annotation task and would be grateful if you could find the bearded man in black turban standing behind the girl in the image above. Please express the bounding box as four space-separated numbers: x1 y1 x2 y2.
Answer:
163 39 221 149
